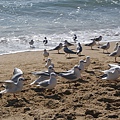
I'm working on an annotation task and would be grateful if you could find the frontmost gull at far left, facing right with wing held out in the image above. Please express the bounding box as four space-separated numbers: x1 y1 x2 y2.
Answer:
0 77 25 97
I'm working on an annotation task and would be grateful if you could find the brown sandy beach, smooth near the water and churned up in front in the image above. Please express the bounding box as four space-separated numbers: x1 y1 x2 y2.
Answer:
0 42 120 120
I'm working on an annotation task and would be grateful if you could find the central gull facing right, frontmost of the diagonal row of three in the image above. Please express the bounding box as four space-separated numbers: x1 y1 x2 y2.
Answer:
59 65 81 81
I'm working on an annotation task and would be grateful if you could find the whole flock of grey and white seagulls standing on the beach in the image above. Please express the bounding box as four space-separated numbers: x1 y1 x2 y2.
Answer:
0 35 120 97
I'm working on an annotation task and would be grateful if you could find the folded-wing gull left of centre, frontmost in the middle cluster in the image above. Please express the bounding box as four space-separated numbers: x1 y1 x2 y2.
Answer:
37 72 57 89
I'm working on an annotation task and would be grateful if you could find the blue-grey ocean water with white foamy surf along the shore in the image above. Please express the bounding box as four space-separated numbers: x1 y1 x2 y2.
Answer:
0 0 120 54
